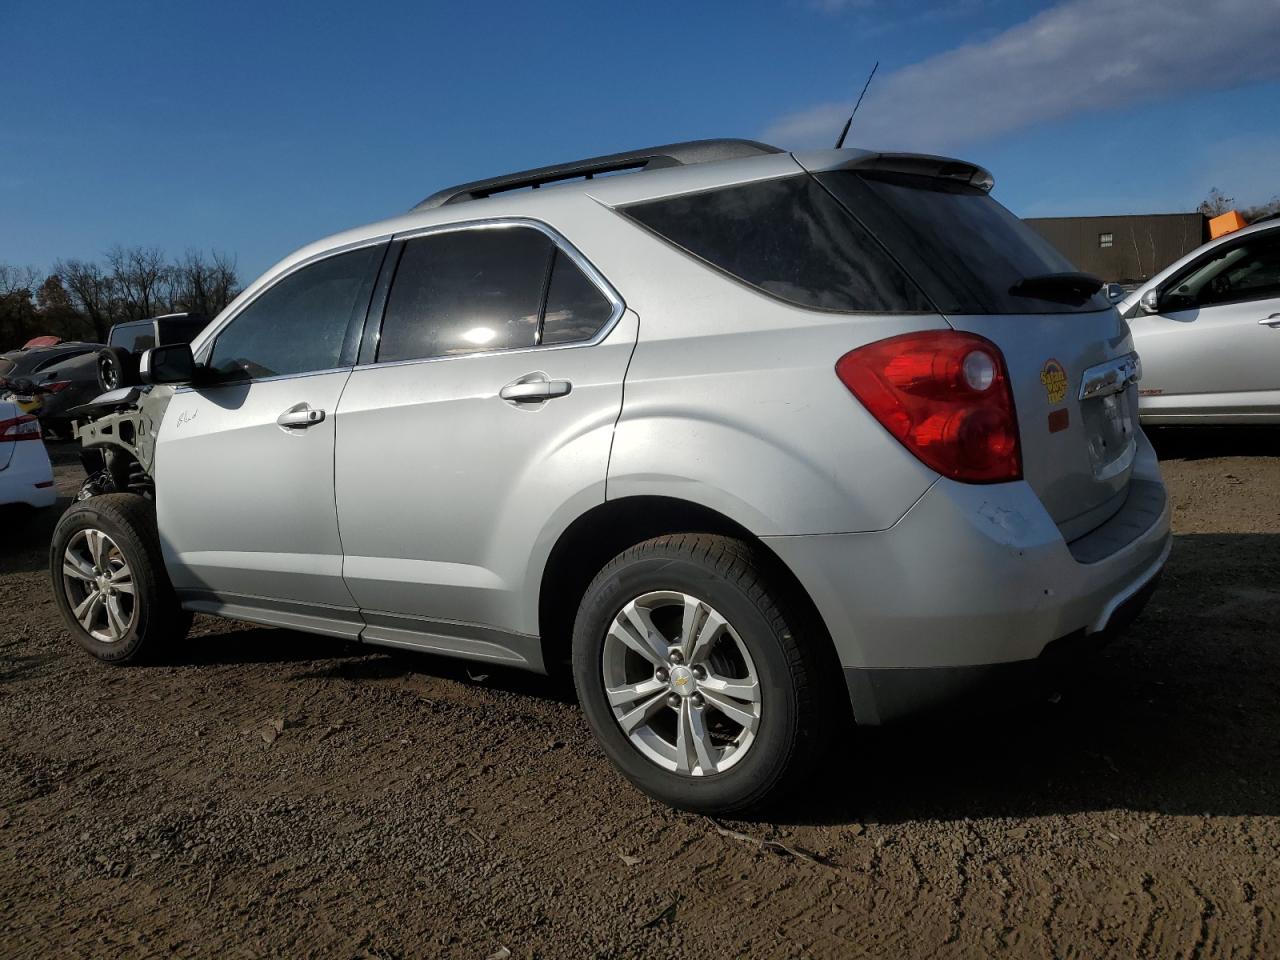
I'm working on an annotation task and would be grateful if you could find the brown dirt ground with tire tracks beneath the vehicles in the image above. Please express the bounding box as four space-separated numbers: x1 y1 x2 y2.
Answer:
0 430 1280 959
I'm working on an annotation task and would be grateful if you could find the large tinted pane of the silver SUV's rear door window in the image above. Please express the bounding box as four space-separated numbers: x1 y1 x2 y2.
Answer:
378 227 556 361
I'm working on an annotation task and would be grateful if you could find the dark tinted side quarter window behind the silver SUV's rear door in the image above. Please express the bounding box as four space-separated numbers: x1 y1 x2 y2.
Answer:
623 174 933 312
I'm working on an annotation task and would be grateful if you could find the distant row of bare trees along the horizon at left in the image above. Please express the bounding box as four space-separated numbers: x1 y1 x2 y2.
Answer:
0 247 241 352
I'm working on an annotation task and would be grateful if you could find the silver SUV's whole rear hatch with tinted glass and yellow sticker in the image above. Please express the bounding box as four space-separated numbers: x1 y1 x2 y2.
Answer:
815 163 1137 540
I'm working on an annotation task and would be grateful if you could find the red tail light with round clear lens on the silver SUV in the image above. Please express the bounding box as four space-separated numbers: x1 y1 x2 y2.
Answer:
836 330 1023 484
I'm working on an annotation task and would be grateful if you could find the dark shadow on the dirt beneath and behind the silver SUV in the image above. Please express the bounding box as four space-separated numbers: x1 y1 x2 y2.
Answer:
147 534 1280 824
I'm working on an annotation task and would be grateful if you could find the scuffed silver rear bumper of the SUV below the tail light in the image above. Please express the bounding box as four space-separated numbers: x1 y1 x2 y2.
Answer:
765 427 1171 723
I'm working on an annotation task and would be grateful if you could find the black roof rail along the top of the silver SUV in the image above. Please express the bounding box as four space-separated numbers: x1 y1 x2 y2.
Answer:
413 140 783 211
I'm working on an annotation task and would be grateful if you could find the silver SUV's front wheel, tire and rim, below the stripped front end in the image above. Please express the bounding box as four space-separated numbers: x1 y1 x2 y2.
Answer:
49 493 192 663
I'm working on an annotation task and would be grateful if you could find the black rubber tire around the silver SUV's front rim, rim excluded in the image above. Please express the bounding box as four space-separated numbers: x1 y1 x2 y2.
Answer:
50 494 163 663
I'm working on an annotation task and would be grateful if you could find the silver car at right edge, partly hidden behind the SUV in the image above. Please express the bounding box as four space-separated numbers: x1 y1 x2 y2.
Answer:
1117 220 1280 425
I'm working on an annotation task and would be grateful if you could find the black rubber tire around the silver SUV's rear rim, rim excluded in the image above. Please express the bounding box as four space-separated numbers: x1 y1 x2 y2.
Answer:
573 548 800 813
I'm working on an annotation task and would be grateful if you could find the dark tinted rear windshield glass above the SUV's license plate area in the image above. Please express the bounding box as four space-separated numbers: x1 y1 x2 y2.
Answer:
818 170 1108 314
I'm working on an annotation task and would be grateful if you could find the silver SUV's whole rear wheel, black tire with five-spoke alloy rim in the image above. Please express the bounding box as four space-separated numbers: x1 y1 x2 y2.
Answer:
573 534 838 814
